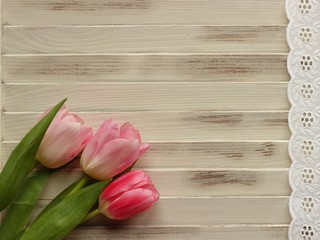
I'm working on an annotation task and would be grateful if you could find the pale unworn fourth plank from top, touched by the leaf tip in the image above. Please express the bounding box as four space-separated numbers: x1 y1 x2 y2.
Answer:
3 83 290 112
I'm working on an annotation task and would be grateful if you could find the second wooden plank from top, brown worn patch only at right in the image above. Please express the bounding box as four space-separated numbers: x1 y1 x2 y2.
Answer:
3 26 288 54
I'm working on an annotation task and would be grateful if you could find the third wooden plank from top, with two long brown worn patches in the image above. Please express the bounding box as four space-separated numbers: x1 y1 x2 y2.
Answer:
3 54 289 83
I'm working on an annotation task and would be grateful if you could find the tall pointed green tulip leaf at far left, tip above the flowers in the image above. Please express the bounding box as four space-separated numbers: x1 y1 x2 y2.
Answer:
0 99 67 211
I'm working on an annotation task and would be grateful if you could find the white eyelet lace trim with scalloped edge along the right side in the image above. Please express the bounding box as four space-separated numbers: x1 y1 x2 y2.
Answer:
286 0 320 240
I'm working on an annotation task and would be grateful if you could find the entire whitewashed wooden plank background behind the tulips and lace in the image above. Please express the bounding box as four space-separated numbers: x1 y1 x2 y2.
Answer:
1 0 290 240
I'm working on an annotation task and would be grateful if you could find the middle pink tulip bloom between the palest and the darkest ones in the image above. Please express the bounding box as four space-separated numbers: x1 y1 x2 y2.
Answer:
80 119 149 180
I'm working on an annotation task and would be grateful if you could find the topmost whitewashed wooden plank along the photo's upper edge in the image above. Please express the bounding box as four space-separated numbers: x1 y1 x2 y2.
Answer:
3 0 288 26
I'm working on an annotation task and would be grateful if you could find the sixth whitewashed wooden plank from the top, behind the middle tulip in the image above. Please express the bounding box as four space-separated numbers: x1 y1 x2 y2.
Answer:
1 141 291 169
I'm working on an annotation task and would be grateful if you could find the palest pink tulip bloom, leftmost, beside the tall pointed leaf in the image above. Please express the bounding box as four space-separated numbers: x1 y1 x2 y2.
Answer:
36 106 93 168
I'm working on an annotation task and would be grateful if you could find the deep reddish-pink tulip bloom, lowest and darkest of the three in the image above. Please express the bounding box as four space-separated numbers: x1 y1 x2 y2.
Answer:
99 170 159 220
